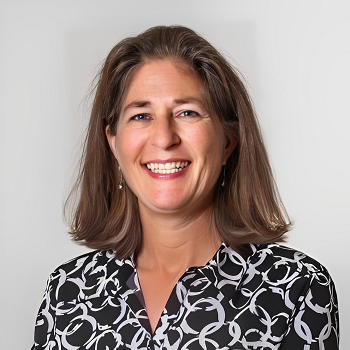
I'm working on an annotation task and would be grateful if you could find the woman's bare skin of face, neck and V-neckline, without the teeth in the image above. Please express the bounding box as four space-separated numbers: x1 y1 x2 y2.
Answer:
106 60 237 331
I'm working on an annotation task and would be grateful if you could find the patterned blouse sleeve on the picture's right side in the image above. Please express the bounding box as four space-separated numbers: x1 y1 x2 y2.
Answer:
280 267 339 350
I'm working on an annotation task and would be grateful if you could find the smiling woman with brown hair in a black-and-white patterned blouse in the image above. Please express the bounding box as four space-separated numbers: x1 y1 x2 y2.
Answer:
33 27 338 350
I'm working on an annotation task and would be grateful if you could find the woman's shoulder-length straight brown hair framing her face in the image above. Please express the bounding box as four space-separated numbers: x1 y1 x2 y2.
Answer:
65 26 291 257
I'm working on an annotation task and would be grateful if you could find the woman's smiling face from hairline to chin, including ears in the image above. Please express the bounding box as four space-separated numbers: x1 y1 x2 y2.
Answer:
107 60 235 214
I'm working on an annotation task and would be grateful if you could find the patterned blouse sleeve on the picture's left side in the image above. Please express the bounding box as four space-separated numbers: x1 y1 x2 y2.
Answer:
31 274 60 350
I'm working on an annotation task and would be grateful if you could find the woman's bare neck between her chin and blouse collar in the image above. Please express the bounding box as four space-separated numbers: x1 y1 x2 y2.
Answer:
137 205 221 274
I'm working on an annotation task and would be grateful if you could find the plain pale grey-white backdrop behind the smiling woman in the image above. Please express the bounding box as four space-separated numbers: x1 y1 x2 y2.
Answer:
0 0 350 350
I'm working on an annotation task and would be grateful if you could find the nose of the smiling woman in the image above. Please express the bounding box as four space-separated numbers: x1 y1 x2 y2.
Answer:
152 113 181 150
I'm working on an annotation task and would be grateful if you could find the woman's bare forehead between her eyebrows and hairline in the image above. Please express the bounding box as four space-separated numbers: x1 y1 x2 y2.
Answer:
124 60 205 104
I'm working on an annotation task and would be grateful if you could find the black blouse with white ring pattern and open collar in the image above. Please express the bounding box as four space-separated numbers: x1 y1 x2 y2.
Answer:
32 244 338 350
